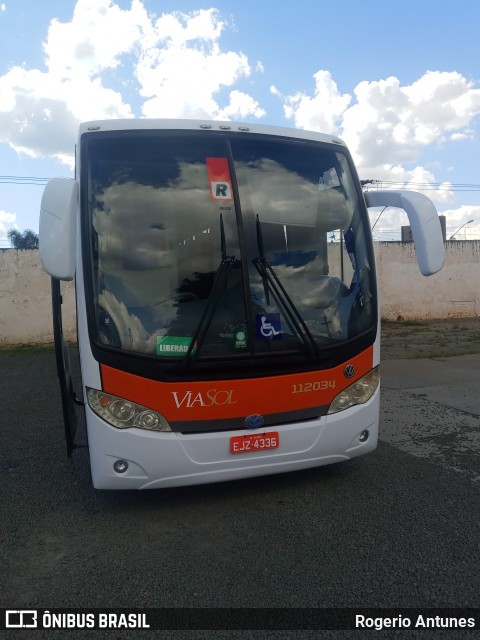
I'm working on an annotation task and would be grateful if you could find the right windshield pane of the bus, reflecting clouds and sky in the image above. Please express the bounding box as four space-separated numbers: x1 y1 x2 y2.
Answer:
233 139 375 351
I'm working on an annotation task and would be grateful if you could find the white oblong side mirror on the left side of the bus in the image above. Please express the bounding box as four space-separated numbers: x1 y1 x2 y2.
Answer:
39 178 78 280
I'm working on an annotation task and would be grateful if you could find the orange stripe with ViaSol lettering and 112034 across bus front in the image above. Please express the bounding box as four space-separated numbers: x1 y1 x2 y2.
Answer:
101 347 373 421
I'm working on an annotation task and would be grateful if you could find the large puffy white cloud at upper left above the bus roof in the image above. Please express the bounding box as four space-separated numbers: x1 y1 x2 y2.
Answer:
0 0 265 162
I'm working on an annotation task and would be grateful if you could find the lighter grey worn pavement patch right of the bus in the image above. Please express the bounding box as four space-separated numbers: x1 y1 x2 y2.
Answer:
380 353 480 488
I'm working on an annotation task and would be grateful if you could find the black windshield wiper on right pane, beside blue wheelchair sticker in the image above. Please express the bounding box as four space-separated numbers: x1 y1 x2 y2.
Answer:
253 214 320 357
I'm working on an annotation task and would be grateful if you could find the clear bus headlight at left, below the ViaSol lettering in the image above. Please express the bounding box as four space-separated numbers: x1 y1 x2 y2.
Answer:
87 387 171 431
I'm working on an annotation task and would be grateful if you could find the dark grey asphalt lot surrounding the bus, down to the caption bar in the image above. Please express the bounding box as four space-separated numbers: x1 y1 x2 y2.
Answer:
0 338 480 640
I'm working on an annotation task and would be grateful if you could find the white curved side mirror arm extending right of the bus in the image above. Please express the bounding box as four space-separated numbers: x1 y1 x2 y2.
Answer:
365 190 445 276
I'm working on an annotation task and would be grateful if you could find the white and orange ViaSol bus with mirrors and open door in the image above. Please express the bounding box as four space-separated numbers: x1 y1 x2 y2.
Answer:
40 119 443 489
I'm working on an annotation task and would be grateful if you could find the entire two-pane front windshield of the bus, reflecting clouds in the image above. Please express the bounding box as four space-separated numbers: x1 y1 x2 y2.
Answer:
82 131 376 366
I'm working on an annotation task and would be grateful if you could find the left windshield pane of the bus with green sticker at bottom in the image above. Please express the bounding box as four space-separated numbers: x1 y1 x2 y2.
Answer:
88 137 245 357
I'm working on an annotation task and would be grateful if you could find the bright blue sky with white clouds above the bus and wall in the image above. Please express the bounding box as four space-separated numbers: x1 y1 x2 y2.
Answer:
0 0 480 248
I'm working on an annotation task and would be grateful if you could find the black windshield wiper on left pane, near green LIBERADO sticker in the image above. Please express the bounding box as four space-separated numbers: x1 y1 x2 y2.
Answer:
183 214 239 368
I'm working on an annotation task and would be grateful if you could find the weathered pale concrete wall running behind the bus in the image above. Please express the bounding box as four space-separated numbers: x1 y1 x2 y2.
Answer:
0 240 480 347
